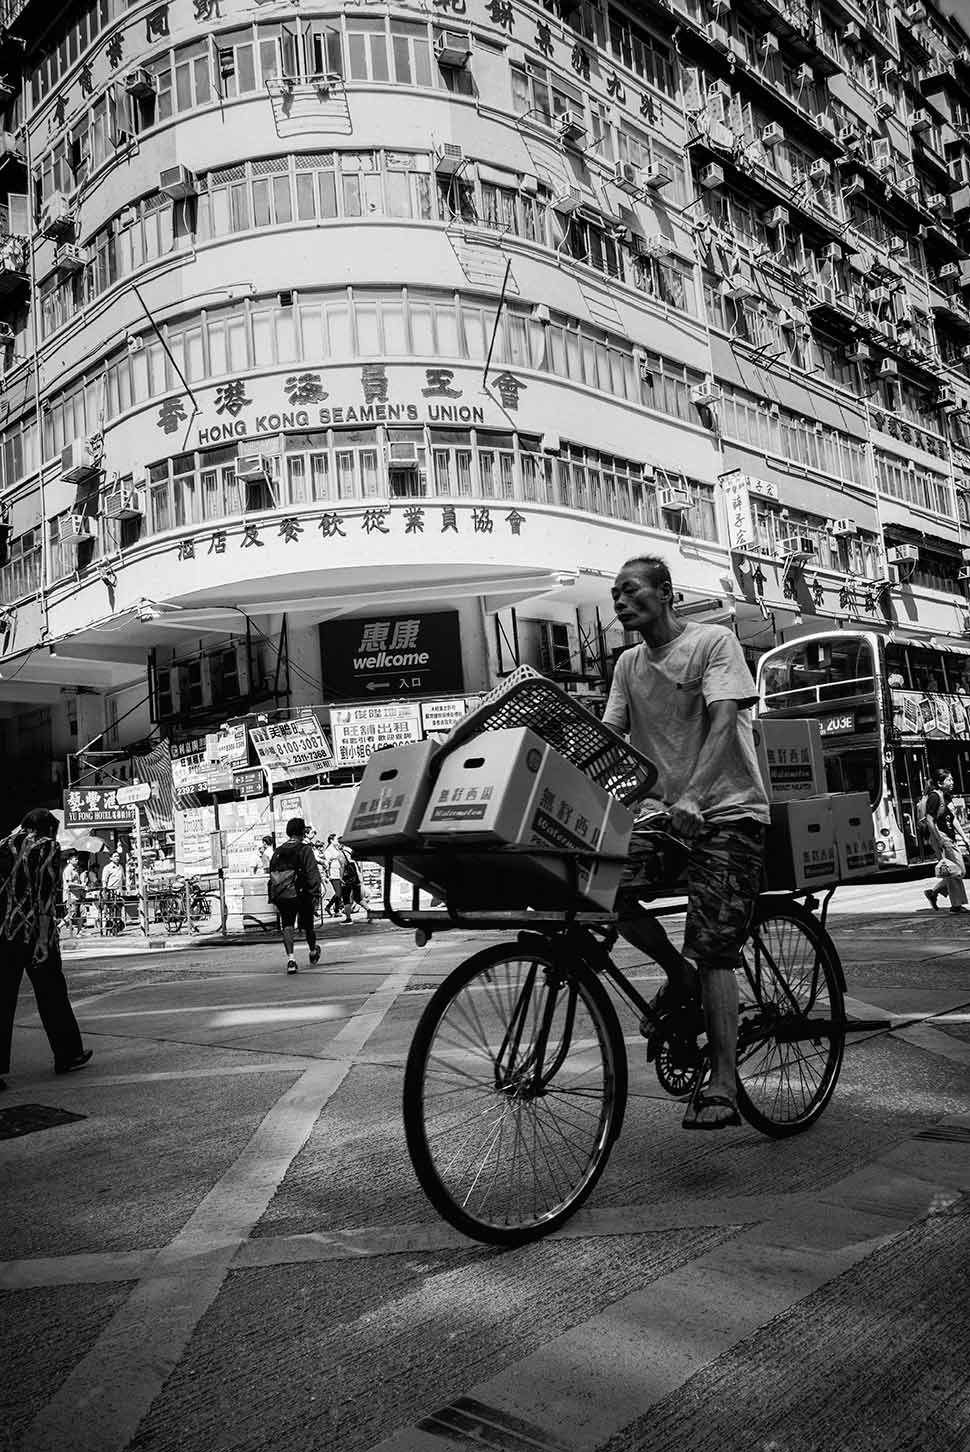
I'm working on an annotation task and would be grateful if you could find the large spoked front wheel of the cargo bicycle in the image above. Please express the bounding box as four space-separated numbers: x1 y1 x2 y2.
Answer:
404 945 627 1246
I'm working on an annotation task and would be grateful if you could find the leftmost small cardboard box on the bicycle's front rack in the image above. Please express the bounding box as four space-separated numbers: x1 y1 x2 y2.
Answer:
344 741 441 854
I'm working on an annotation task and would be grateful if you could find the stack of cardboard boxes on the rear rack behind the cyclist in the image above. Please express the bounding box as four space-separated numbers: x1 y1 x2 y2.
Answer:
754 717 877 889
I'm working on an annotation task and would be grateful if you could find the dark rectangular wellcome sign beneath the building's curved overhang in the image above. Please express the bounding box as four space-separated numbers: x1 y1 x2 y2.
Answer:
319 610 462 701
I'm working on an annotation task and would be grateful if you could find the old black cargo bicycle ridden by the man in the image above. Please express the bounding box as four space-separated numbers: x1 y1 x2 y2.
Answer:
394 849 847 1246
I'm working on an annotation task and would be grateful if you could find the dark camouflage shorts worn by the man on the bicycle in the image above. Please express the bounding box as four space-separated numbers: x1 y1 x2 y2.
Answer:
616 817 765 968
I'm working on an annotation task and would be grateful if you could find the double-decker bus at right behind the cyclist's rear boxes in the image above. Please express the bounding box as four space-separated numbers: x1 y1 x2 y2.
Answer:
758 630 970 867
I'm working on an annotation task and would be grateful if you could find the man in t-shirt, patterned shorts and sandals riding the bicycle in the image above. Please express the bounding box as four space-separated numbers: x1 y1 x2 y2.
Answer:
603 556 770 1130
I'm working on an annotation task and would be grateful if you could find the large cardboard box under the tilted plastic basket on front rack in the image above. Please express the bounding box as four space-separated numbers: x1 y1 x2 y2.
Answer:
418 727 635 908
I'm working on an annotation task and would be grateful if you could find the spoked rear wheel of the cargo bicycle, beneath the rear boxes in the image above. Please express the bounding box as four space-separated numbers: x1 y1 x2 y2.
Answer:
738 902 845 1138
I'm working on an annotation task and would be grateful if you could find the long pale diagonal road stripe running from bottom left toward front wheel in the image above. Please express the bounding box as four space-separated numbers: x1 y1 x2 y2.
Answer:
23 953 420 1452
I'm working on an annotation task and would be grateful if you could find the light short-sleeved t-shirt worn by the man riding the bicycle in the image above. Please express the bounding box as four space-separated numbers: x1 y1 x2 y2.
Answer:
603 620 770 822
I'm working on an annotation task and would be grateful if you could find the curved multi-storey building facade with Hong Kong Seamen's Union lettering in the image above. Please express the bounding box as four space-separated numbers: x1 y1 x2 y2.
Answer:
0 0 970 815
